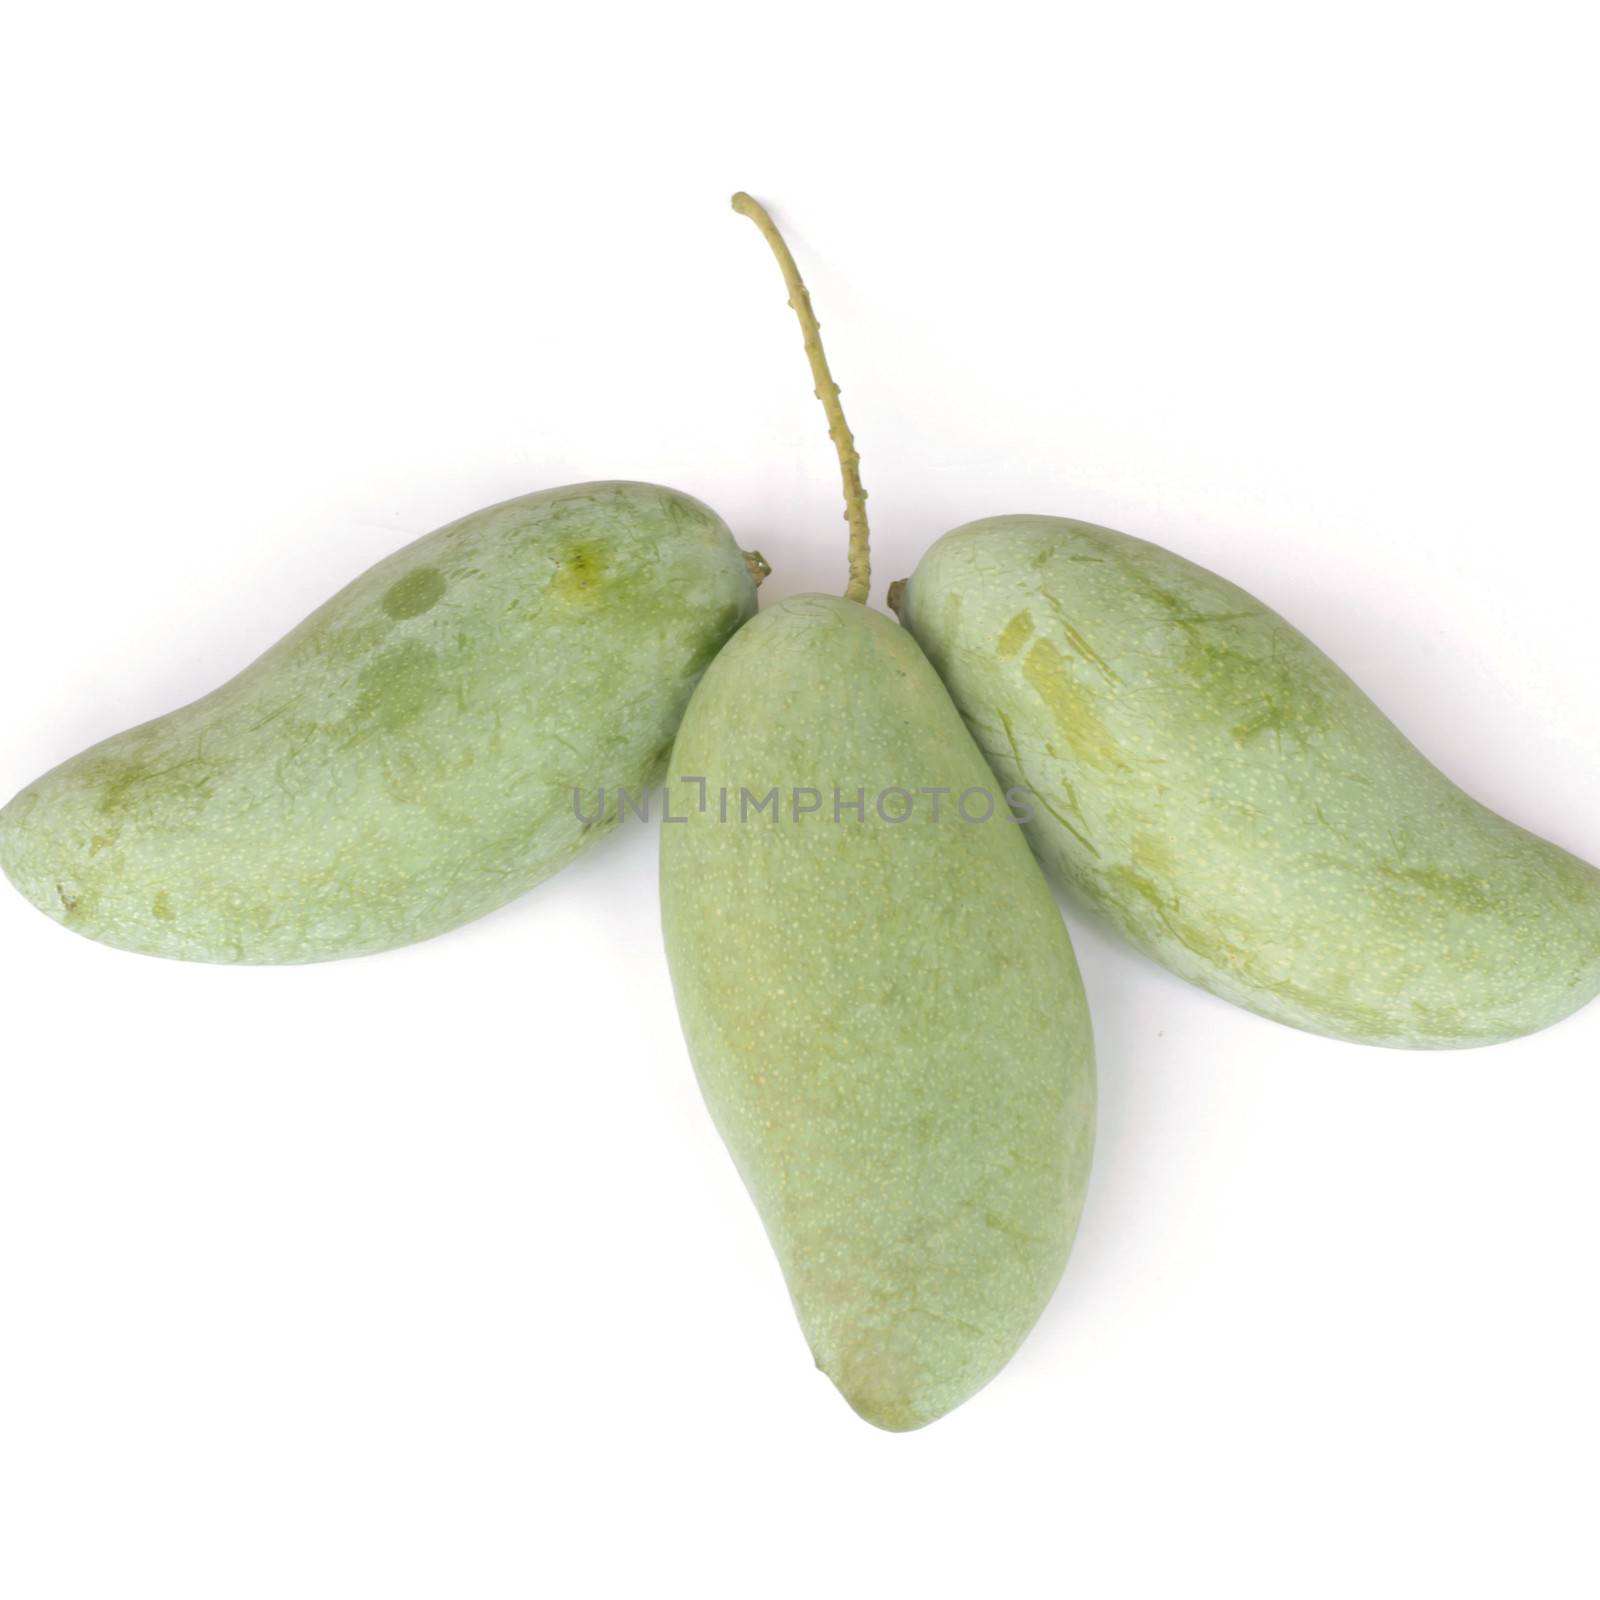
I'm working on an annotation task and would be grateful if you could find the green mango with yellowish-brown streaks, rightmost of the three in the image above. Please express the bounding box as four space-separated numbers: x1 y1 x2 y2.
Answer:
899 517 1600 1050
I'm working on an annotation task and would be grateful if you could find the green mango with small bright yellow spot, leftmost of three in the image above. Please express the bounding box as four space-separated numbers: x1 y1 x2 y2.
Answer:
0 483 755 962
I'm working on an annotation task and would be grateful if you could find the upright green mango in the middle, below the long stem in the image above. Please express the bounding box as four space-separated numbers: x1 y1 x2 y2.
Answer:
661 595 1094 1430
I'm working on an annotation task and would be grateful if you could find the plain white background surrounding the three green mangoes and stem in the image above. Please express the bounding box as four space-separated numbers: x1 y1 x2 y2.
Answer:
0 0 1600 1600
